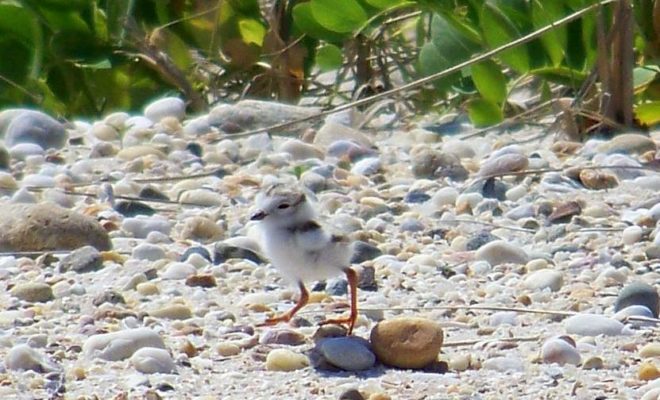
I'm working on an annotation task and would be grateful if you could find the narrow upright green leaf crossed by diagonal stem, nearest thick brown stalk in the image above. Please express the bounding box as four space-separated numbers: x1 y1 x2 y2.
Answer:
532 0 568 65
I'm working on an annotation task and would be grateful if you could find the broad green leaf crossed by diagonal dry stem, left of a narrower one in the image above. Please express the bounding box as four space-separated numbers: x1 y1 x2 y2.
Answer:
480 2 529 73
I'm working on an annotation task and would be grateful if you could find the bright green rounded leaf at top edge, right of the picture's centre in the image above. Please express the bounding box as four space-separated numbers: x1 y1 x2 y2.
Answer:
310 0 368 33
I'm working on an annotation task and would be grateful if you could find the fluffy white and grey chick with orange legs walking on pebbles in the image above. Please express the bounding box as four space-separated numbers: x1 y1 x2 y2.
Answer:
250 184 357 335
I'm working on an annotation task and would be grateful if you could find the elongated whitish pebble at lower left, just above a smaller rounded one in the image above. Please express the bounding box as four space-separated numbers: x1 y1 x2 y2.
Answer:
82 328 165 361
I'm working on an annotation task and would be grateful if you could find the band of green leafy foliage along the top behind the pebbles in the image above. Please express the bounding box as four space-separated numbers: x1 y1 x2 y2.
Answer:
0 0 660 130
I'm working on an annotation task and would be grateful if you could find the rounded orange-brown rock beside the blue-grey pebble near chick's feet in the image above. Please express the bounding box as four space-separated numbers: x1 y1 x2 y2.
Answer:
371 317 444 368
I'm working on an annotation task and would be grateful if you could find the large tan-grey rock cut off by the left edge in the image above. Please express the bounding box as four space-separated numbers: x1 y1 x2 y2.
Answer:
0 203 112 251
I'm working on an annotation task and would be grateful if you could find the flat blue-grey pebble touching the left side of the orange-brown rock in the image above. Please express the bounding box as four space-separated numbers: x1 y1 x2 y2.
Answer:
319 336 376 371
